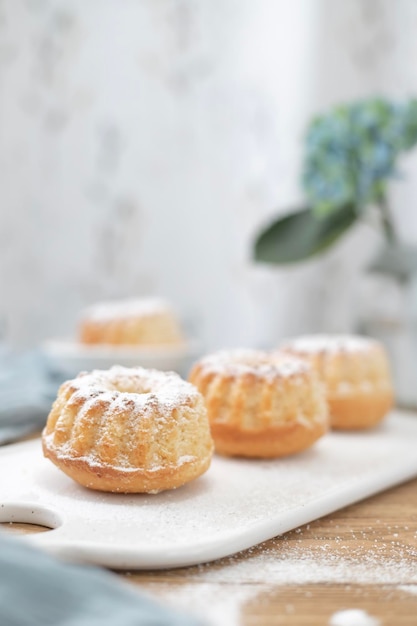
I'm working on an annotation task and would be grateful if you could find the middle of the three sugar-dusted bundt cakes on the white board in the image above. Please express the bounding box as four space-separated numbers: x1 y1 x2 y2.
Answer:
189 350 328 458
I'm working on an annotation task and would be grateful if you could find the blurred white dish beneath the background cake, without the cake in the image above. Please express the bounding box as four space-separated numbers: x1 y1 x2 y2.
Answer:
42 340 199 377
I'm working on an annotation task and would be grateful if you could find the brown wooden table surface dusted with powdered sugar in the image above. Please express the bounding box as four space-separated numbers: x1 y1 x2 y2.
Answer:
4 472 417 626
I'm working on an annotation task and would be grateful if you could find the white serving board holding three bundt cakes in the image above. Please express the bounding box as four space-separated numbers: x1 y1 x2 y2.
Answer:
0 412 417 569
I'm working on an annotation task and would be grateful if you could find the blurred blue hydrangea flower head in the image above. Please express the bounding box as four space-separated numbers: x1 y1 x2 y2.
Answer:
302 98 417 215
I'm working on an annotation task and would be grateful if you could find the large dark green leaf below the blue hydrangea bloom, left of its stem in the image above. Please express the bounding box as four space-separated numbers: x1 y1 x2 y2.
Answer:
253 204 358 265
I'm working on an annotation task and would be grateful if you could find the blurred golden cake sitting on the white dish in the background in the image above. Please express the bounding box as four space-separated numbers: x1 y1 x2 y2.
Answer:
79 298 184 346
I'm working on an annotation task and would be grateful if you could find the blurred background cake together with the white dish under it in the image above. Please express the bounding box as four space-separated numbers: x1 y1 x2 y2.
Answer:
43 298 200 379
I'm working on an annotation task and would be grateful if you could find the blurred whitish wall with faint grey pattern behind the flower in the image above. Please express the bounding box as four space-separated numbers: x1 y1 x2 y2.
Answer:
0 0 417 349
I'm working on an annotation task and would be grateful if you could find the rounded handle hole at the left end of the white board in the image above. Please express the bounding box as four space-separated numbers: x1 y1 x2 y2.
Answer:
0 502 62 534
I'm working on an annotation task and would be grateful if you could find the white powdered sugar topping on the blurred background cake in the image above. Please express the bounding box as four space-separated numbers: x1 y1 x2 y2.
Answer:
83 298 171 322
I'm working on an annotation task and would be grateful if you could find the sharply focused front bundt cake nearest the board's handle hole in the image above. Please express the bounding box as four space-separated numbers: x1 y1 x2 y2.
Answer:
42 366 213 493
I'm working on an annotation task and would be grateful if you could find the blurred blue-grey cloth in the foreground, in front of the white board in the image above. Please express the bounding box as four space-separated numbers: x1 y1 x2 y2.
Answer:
0 532 201 626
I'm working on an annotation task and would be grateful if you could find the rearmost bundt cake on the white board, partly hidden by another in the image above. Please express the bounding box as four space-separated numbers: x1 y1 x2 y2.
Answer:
281 335 394 429
